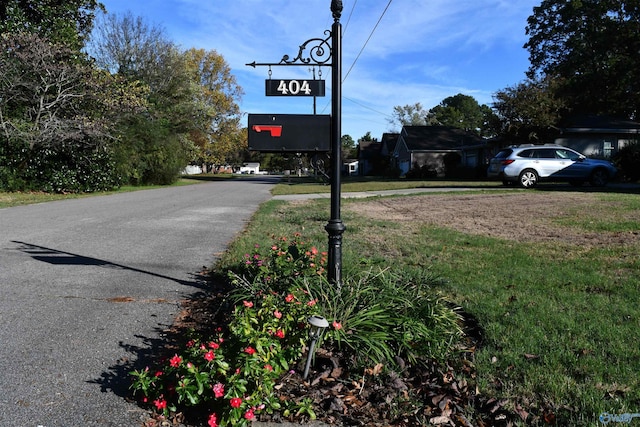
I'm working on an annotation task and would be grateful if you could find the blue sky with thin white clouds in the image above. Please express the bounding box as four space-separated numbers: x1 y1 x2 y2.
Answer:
92 0 541 140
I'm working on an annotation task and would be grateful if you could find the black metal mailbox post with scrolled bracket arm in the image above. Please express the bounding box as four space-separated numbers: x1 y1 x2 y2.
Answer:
247 0 346 286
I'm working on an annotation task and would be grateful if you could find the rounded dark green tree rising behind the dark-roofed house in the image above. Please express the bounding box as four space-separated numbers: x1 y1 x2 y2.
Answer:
426 93 497 137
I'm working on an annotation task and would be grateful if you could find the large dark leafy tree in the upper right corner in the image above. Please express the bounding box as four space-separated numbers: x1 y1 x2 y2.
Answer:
524 0 640 118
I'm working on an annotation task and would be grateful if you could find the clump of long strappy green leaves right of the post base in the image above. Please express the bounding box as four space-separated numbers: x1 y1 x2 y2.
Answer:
308 269 464 367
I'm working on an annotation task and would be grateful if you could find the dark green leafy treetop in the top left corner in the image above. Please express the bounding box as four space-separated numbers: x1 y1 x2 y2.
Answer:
0 0 104 51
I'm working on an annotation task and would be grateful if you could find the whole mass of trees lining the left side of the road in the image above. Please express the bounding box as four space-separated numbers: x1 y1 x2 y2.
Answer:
0 4 246 192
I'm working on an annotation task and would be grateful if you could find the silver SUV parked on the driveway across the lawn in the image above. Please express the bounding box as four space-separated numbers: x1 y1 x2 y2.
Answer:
487 145 617 188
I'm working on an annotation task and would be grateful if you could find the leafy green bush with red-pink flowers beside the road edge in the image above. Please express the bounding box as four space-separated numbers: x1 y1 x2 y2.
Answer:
131 236 324 427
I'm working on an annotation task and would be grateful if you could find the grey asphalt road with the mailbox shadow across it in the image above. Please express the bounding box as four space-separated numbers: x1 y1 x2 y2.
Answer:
0 177 276 427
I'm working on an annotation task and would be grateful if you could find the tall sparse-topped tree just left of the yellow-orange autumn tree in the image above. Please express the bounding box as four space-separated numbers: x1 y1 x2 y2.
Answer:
88 13 198 184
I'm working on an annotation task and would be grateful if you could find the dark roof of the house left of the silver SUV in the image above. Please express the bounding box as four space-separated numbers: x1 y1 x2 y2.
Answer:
400 126 486 151
